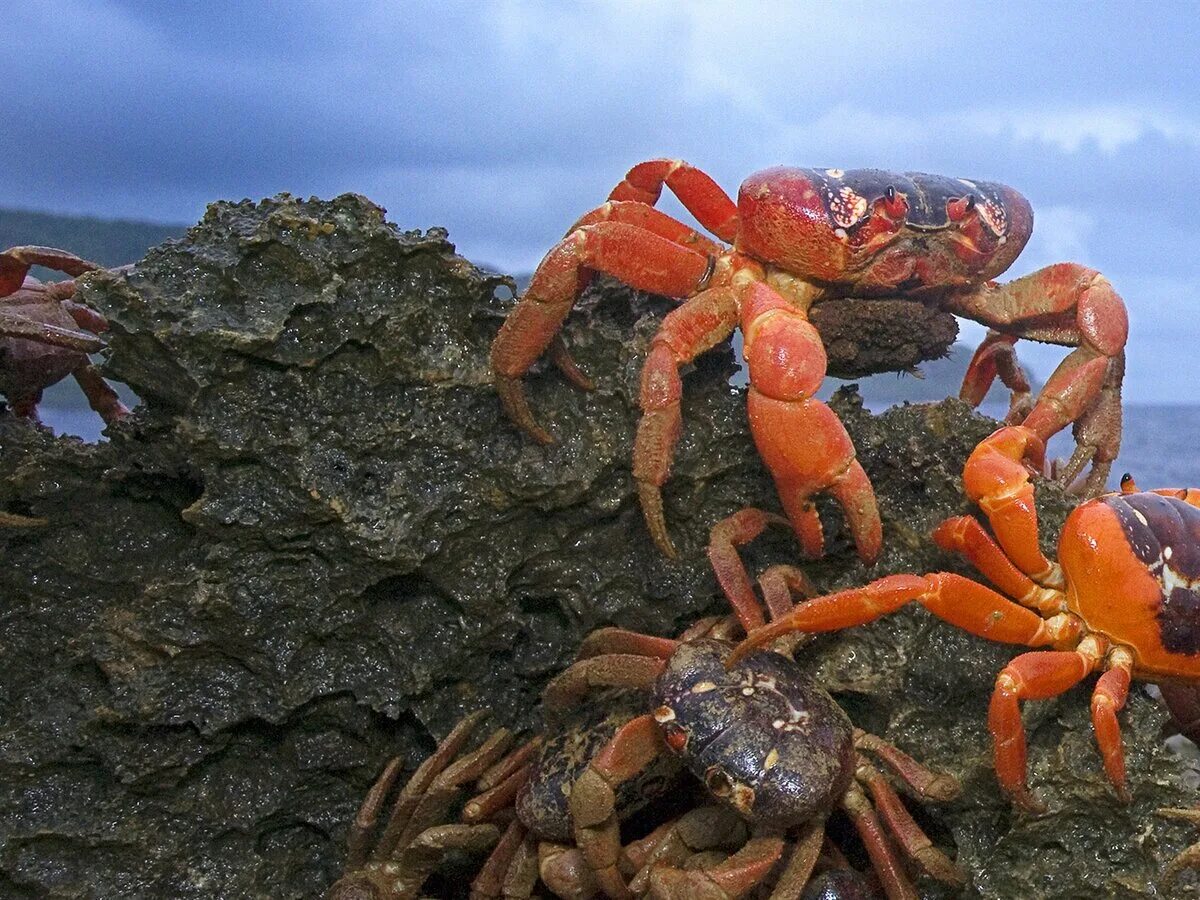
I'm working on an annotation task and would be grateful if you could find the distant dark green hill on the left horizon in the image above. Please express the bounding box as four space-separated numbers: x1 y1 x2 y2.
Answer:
0 209 187 265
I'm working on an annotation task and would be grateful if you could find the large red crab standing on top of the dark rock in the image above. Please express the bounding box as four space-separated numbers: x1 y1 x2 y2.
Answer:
492 160 1128 562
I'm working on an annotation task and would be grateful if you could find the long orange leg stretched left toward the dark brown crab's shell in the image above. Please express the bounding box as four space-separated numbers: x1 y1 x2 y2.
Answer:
726 572 1078 666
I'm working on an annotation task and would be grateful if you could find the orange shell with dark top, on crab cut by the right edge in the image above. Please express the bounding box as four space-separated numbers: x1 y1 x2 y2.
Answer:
1058 491 1200 680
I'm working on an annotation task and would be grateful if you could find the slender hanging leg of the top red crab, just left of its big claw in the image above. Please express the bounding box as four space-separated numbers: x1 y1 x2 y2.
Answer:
634 284 738 558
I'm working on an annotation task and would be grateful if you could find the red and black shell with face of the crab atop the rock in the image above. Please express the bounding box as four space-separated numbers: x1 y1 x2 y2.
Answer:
736 167 1033 296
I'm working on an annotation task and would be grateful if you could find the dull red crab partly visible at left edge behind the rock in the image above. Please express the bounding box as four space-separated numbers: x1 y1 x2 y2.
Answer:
0 247 128 425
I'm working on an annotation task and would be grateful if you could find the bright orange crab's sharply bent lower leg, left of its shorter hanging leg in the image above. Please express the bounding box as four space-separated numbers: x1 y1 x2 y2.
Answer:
988 646 1099 811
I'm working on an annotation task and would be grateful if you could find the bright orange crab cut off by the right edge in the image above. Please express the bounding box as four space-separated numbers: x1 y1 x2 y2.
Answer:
730 426 1200 810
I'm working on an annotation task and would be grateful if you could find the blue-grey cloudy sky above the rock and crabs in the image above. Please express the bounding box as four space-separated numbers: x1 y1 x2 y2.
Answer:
0 0 1200 402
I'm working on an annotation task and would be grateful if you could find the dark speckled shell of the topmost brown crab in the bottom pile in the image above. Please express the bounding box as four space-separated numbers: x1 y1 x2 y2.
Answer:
654 638 854 828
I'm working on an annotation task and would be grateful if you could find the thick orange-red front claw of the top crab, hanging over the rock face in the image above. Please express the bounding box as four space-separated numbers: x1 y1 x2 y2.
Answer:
742 281 883 563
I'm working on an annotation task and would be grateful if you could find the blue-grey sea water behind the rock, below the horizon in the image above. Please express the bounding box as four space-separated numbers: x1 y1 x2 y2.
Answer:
38 403 1200 490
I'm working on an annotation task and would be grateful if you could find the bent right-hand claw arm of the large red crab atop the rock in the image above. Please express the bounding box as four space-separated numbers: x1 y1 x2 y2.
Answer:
948 263 1129 496
